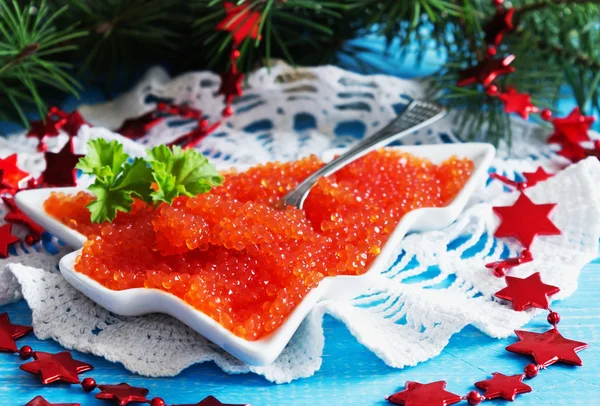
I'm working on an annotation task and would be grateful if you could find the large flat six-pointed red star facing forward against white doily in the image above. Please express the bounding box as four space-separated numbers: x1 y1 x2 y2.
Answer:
492 193 560 248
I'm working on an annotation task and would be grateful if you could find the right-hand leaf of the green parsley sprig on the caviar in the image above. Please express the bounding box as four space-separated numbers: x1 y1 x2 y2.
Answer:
148 145 223 204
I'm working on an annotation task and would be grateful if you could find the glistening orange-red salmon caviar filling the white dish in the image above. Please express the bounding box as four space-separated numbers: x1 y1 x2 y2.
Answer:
44 149 473 340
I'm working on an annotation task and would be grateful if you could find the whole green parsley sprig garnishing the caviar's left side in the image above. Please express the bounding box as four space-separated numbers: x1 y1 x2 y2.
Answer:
76 138 223 223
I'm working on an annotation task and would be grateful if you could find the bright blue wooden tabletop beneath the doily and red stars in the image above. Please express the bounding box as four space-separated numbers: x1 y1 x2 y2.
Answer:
0 56 600 406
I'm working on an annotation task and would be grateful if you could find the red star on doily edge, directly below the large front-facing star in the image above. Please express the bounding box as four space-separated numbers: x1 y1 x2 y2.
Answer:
495 272 560 312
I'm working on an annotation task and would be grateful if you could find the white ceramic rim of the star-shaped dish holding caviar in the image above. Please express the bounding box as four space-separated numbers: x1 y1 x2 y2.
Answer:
16 143 495 365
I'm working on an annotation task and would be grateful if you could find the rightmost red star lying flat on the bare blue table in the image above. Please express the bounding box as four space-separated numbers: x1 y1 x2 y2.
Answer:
506 329 587 366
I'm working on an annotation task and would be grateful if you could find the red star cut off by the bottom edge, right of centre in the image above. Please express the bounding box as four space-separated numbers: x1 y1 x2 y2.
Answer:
387 381 462 406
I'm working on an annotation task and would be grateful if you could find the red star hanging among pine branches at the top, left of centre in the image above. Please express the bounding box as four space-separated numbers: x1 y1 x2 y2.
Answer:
217 2 262 48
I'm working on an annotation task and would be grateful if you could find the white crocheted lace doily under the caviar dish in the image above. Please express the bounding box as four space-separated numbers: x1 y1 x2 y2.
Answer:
0 65 600 383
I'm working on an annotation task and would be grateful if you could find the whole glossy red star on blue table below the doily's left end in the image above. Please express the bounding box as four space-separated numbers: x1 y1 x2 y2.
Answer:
21 351 92 385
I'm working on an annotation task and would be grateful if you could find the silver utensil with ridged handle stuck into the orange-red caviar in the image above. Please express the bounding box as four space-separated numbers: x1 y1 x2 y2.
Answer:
277 100 446 209
